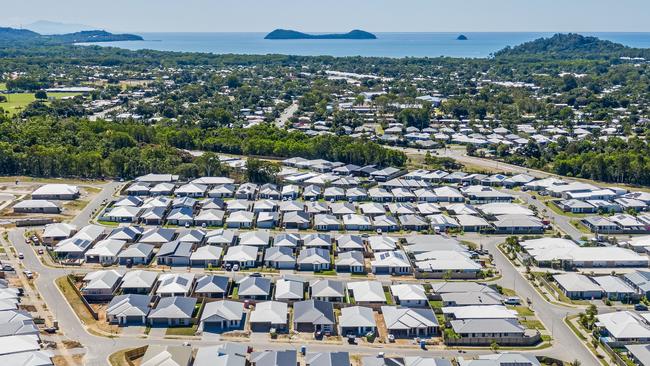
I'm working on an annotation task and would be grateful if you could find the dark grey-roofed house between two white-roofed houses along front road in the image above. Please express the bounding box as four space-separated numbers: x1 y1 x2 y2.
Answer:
293 300 336 333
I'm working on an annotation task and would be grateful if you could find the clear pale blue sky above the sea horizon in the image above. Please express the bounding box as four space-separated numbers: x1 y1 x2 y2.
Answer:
0 0 650 33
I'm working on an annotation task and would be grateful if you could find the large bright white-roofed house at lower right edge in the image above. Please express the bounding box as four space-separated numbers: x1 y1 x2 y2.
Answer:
595 310 650 347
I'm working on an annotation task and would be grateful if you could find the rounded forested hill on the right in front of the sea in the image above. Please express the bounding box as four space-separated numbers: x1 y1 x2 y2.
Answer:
494 33 650 59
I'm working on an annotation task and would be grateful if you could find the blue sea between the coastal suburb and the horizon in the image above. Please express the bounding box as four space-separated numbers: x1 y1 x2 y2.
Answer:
79 32 650 58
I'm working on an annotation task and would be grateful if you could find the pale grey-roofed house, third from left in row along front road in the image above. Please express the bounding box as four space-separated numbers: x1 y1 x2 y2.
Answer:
200 300 244 332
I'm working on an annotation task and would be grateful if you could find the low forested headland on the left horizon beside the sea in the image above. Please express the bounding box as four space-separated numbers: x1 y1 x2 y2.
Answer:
0 28 142 44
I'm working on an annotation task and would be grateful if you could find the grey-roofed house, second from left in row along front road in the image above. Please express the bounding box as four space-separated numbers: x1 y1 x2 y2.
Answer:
148 296 196 328
